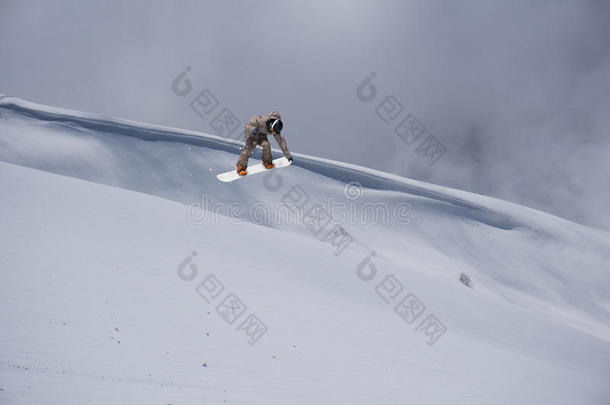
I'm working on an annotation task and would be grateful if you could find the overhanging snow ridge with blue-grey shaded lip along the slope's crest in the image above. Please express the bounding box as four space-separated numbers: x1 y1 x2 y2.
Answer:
0 96 526 230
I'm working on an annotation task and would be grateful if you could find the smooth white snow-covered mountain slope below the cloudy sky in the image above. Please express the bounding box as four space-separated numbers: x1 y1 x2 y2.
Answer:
0 97 610 404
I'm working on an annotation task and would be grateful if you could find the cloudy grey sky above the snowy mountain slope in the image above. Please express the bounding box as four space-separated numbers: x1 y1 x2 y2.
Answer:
0 0 610 230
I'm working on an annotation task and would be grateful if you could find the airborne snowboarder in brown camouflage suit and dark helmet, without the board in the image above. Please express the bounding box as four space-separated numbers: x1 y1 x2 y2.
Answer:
236 111 292 176
